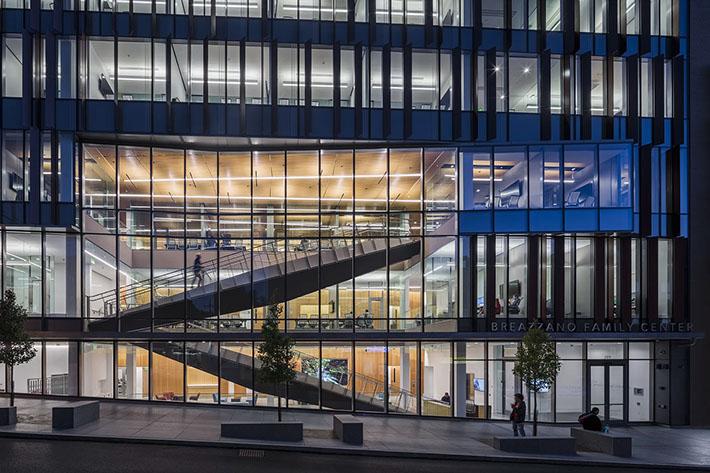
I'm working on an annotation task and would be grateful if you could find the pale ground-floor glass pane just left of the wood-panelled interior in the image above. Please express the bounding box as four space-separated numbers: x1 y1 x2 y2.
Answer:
80 342 113 397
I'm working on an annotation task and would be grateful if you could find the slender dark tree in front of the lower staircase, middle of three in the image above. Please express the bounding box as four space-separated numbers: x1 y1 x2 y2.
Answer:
259 299 296 422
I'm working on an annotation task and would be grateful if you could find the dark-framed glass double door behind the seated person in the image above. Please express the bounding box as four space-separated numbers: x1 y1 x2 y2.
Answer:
587 361 626 424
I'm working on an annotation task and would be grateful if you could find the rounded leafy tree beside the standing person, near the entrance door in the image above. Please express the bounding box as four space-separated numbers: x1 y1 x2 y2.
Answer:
513 327 561 436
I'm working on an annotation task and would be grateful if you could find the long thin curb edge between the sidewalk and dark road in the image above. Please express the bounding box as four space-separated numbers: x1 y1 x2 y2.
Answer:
0 431 708 471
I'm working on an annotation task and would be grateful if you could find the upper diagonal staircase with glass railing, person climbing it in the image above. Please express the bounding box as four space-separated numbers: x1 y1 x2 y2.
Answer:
88 238 420 332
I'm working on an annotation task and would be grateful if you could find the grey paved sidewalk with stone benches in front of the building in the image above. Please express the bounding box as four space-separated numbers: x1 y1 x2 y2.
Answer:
0 399 710 470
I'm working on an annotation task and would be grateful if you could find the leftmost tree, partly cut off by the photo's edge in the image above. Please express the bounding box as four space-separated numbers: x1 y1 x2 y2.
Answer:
0 290 37 406
